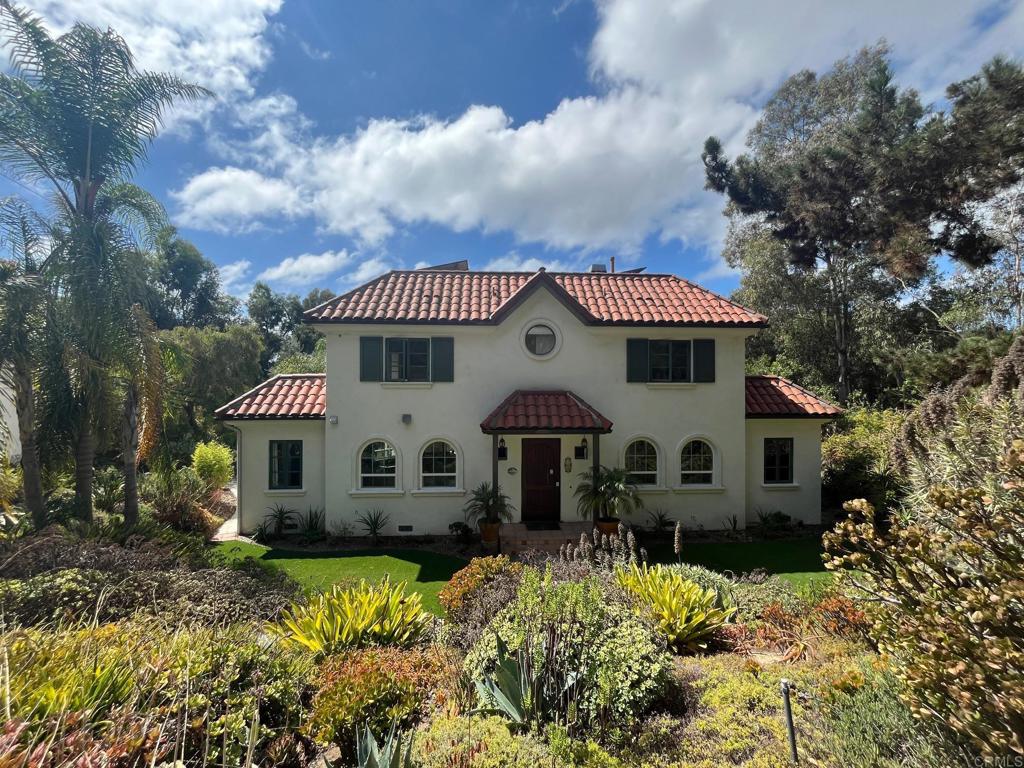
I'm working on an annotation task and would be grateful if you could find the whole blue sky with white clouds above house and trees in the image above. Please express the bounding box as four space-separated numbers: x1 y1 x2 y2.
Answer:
9 0 1024 295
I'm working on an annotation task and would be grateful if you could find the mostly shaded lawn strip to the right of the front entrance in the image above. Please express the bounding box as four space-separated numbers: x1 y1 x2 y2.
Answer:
647 539 831 586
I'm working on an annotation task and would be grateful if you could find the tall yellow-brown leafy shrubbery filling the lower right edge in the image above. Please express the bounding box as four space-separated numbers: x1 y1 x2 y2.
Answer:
825 378 1024 758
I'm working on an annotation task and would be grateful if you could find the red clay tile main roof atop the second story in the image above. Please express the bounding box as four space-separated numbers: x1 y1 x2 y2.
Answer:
305 269 768 328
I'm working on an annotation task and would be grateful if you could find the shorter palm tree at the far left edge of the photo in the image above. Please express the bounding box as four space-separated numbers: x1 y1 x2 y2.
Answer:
0 198 46 529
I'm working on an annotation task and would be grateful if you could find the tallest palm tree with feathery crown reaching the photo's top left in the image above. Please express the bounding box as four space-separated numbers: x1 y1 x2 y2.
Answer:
0 0 209 519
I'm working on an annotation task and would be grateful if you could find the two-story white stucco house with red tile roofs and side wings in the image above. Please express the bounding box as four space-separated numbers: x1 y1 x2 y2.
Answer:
217 262 839 535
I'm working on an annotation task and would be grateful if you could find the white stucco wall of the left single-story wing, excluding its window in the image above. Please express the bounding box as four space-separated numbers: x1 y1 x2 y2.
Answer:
226 420 330 532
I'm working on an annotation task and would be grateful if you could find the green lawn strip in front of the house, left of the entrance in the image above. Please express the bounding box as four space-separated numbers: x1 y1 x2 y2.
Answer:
215 542 466 615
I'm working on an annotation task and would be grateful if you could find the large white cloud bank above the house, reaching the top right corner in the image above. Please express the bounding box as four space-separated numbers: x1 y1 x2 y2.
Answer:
163 0 1024 260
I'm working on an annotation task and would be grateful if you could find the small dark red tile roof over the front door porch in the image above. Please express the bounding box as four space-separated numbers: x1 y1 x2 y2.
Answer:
480 389 611 432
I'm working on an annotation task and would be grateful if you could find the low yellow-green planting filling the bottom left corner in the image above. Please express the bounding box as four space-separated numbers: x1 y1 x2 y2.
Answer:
6 621 309 766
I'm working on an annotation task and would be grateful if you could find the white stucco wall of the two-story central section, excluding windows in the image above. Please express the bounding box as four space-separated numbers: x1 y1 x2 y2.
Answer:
319 290 750 534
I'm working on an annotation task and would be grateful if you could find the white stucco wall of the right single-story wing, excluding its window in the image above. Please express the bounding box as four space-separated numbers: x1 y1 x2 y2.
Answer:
746 419 825 525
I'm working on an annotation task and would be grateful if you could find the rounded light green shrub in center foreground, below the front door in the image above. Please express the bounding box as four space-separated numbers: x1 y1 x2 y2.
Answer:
464 567 671 732
